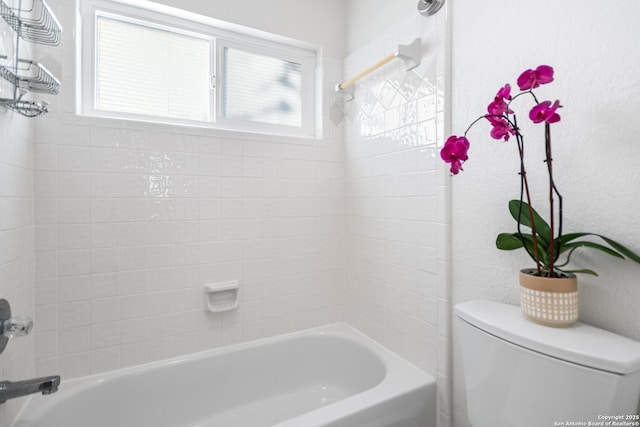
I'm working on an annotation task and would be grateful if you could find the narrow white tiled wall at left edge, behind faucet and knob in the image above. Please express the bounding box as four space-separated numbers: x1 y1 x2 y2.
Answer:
0 108 34 426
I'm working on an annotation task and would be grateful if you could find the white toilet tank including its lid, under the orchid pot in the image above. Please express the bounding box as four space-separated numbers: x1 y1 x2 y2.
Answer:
455 301 640 427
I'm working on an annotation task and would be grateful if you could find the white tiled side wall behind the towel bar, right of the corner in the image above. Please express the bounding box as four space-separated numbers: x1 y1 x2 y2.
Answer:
344 12 451 426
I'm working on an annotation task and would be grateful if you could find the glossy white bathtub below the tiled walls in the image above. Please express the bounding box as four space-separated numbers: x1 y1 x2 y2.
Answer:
13 324 436 427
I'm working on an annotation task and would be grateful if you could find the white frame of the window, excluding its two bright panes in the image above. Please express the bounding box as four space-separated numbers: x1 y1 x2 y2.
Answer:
76 0 319 138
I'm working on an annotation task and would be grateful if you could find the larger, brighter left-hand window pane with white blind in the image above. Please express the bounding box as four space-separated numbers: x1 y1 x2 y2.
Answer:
95 16 213 122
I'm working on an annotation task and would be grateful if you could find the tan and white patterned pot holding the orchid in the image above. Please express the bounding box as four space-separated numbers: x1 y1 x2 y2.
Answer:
520 269 578 328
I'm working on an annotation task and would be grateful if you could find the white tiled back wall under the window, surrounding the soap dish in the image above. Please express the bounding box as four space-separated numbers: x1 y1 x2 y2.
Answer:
34 1 344 378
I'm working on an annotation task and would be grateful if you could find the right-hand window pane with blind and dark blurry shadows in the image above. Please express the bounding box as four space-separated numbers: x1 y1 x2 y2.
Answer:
223 47 302 127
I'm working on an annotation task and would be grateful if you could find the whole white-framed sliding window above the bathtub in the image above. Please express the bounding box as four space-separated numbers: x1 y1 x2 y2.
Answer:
79 0 316 136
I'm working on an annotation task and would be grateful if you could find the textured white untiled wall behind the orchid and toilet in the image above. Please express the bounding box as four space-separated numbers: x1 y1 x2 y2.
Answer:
451 0 640 426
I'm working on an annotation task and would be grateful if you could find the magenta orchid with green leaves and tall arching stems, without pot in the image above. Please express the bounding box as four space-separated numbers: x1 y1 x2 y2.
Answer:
440 65 640 277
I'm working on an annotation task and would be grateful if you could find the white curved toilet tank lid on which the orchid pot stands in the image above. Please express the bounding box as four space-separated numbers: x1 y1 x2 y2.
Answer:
455 300 640 375
